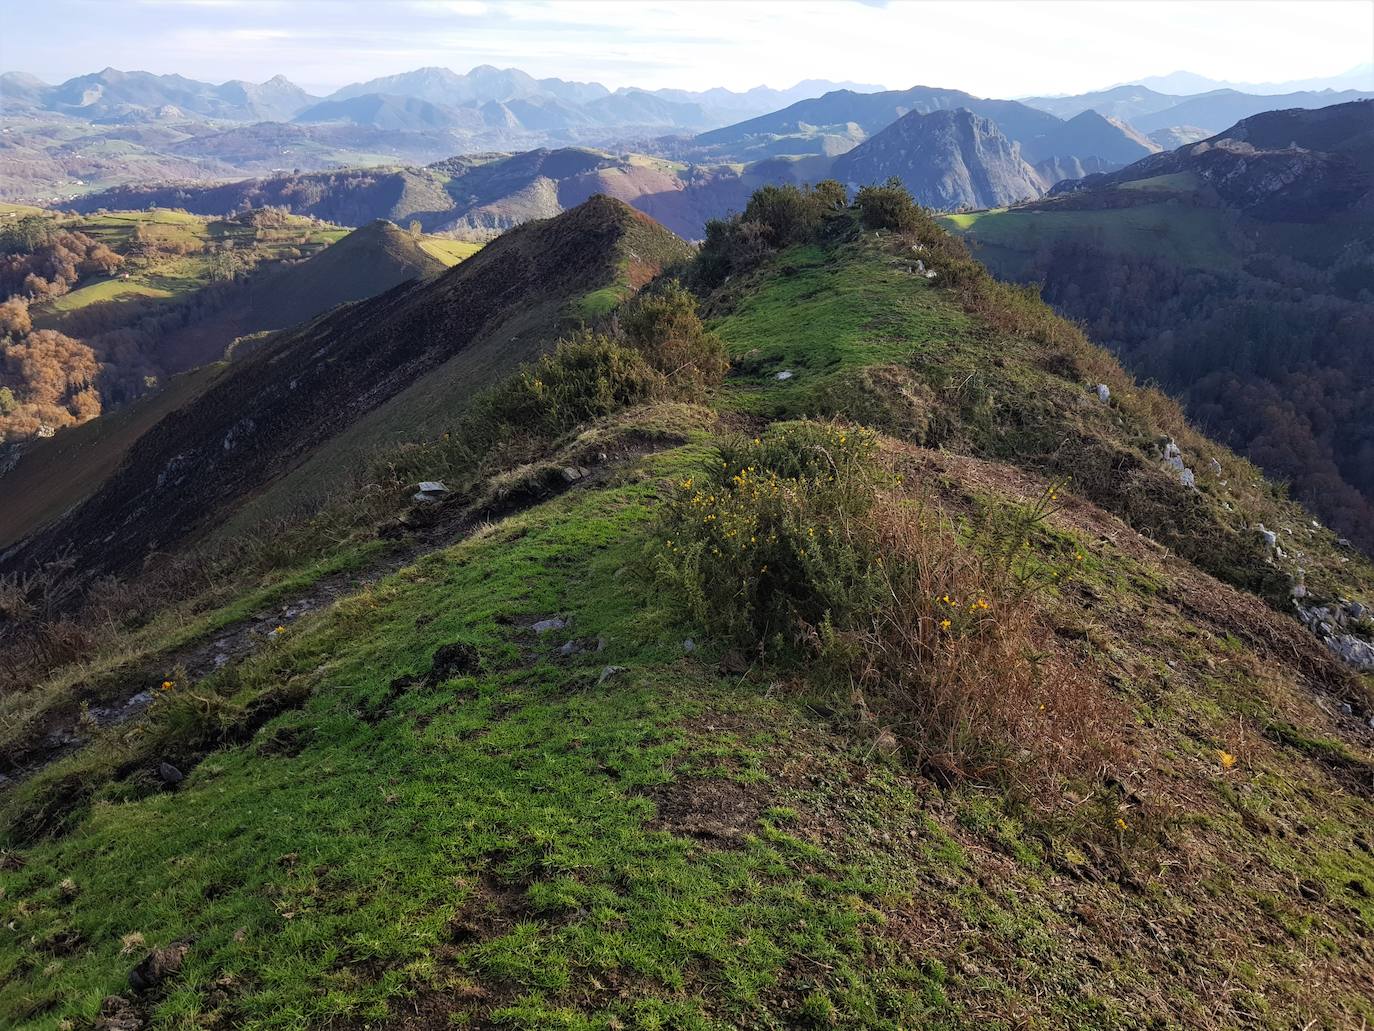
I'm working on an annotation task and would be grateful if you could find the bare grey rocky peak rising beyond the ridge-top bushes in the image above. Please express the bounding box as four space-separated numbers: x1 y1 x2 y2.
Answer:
831 109 1044 212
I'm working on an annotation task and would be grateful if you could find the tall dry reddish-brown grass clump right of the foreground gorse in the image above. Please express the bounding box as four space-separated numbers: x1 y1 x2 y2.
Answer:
838 499 1125 795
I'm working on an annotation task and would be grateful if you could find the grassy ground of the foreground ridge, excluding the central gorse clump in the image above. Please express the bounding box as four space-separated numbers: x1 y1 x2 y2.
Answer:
0 203 1374 1031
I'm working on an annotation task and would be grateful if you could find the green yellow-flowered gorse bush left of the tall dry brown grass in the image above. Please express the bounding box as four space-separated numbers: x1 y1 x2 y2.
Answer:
655 423 878 656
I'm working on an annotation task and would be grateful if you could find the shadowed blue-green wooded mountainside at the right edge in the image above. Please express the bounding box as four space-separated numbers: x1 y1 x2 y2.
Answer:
952 102 1374 550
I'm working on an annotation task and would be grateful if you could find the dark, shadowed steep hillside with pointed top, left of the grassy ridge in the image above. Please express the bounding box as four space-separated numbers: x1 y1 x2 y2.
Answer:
0 198 684 577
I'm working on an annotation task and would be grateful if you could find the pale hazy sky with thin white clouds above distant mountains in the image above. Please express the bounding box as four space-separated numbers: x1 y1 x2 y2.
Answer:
0 0 1374 96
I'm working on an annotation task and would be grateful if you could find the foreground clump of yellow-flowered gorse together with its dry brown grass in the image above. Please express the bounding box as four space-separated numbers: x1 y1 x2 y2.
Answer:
653 422 1113 792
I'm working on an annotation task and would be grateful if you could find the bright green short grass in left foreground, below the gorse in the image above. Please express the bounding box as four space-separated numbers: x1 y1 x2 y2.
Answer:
0 458 956 1028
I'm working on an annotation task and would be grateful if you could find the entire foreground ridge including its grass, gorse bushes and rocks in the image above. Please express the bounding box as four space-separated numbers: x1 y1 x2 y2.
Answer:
0 188 1374 1030
